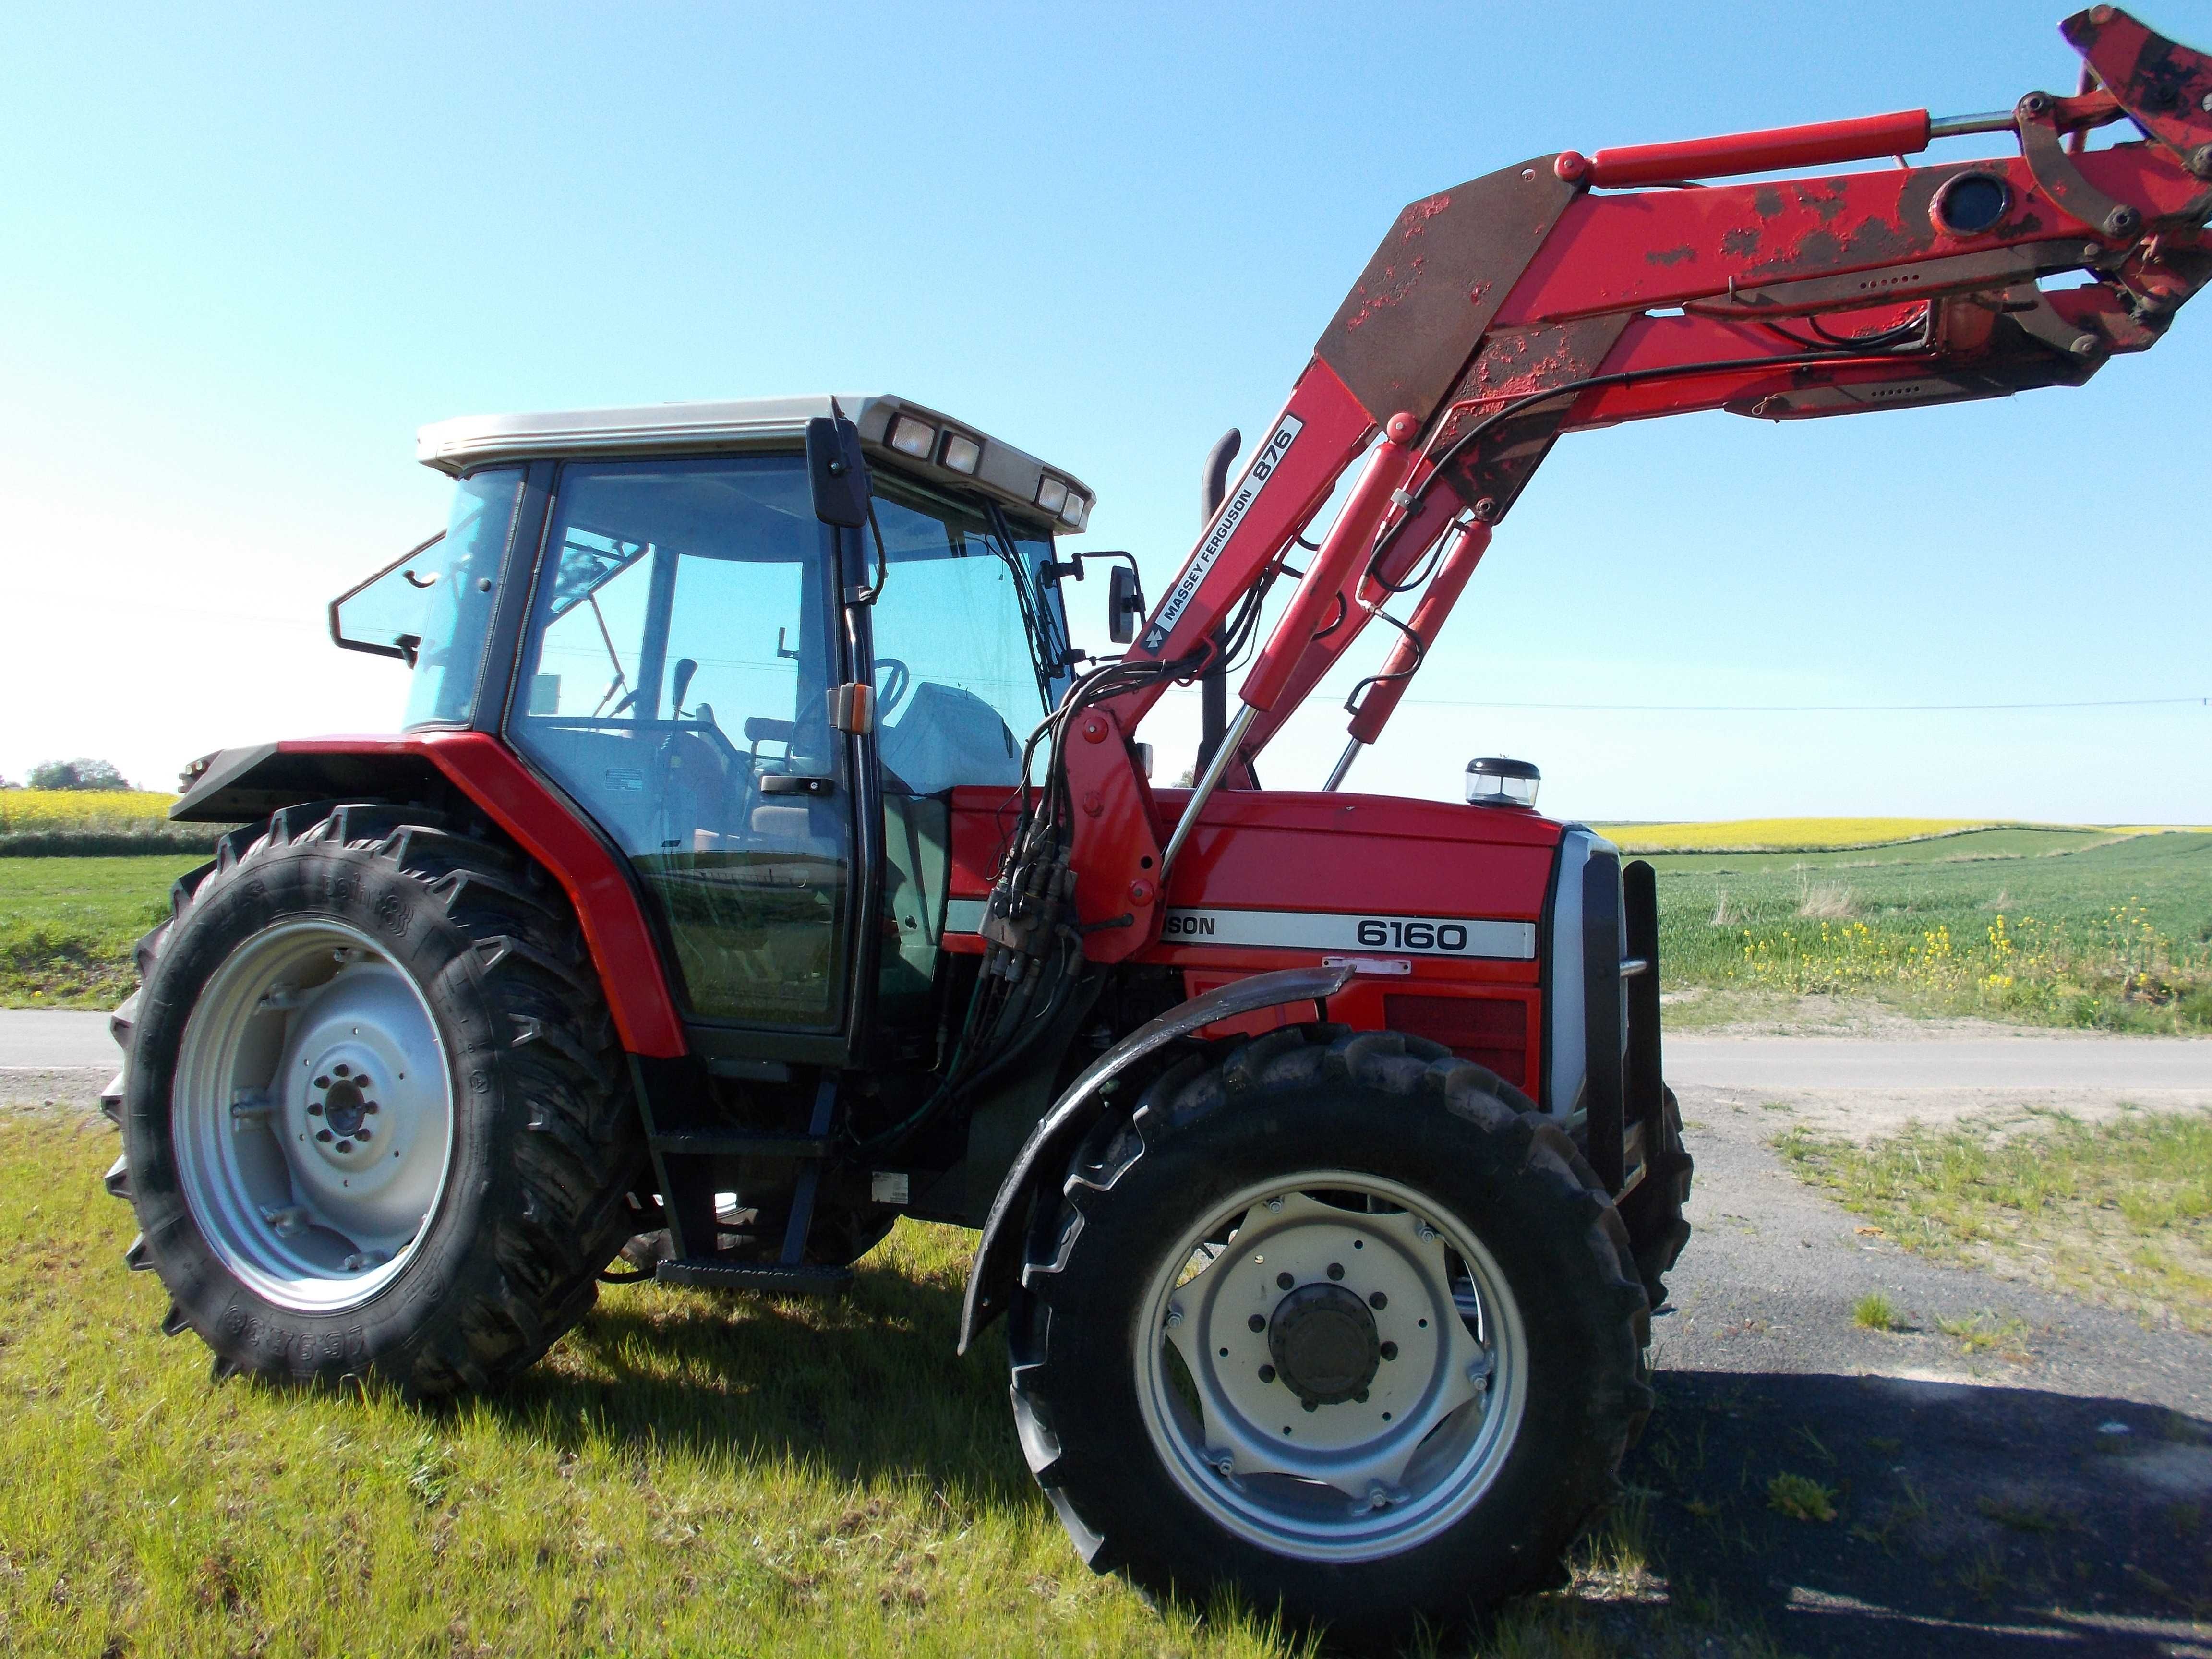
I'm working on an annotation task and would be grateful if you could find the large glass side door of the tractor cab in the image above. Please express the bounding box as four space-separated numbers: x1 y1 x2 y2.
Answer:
509 456 874 1058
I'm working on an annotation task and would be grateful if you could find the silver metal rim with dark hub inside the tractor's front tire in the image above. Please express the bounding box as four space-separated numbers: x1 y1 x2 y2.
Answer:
1132 1170 1528 1562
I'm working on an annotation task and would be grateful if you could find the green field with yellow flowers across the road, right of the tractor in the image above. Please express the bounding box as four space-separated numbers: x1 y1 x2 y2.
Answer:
1650 830 2212 1033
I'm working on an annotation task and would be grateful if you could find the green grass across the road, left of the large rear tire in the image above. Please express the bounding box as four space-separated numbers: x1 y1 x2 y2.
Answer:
0 854 206 1009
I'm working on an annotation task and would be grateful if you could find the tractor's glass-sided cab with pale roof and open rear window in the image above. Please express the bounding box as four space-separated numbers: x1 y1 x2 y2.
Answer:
332 396 1093 1064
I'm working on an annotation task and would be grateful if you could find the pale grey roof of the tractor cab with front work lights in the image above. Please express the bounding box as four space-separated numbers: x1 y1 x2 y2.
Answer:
416 394 1093 531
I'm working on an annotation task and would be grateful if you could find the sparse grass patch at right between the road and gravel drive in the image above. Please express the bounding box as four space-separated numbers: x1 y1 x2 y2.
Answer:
1776 1110 2212 1351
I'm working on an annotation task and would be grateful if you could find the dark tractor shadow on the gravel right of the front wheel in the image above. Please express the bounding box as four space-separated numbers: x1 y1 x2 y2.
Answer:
1588 1371 2212 1659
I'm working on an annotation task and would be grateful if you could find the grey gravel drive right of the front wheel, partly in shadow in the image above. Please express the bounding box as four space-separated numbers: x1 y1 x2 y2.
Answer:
1622 1070 2212 1655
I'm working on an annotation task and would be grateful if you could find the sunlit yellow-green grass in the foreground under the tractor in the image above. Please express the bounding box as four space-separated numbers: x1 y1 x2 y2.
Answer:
0 1113 1772 1659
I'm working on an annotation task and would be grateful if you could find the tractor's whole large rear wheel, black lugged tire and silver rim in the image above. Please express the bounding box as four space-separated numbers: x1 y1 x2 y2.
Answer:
108 805 644 1396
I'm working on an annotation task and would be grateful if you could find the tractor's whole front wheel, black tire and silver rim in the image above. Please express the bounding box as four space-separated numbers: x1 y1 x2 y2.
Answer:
1011 1026 1650 1633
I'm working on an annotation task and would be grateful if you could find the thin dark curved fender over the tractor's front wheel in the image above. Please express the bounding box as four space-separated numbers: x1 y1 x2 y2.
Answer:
960 962 1356 1354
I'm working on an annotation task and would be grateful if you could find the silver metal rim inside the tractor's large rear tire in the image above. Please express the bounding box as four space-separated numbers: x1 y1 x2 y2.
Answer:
170 918 454 1314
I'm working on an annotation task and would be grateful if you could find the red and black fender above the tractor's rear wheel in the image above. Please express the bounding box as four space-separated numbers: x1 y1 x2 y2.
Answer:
168 730 685 1059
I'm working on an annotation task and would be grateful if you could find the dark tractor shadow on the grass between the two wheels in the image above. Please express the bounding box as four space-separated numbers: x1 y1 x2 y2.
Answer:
467 1261 1042 1504
